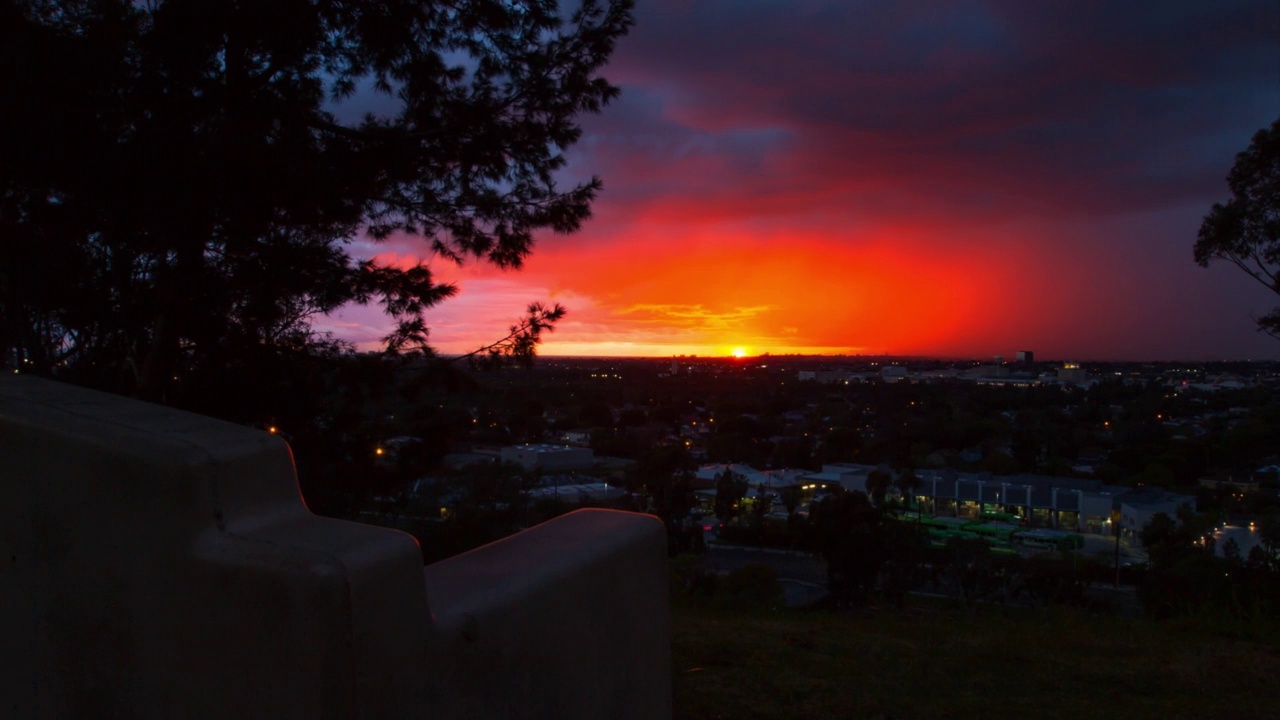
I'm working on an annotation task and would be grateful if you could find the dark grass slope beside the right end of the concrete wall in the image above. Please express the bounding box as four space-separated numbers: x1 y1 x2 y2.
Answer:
672 600 1280 720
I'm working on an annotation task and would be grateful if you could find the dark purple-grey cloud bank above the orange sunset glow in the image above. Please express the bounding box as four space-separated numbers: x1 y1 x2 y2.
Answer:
591 0 1280 224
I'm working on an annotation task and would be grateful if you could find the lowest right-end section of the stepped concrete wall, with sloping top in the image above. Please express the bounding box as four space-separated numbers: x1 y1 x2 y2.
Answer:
426 510 671 719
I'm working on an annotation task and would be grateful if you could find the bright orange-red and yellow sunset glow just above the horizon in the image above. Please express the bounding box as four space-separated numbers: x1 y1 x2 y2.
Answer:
332 229 1049 356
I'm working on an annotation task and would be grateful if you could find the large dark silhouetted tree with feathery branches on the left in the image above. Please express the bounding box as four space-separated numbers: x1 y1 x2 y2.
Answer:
0 0 632 407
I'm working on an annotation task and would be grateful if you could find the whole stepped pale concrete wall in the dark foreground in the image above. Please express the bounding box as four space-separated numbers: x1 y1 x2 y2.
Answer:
0 377 671 717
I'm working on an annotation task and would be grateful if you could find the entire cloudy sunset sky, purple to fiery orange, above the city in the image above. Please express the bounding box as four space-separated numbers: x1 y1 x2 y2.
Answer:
323 0 1280 360
